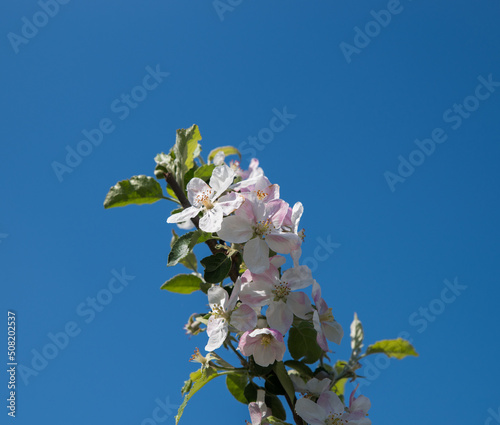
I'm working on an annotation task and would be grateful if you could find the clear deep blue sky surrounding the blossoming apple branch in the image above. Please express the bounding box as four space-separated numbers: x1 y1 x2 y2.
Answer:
0 0 500 425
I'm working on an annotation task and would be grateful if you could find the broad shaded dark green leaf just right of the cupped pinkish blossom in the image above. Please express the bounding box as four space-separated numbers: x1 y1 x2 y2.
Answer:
288 321 323 364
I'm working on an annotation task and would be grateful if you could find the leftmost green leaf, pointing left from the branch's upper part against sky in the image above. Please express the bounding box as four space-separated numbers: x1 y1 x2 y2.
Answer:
104 176 164 209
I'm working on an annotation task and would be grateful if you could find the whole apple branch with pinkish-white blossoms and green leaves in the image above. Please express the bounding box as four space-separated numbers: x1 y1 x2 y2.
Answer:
104 125 417 425
